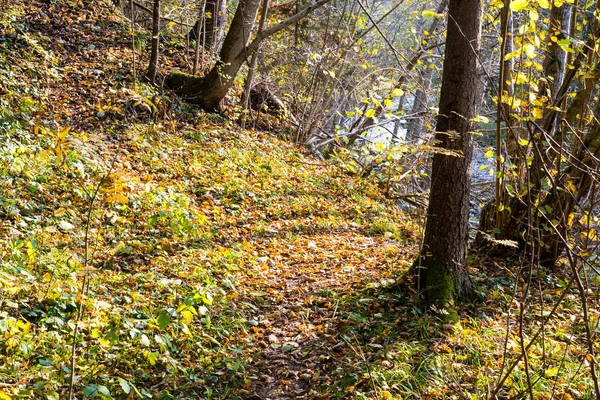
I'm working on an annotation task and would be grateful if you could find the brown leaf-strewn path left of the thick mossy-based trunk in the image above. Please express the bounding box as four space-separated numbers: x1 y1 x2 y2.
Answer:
237 230 411 400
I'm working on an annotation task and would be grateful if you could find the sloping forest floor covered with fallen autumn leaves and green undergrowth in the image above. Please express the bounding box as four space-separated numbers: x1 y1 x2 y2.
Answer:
0 0 595 400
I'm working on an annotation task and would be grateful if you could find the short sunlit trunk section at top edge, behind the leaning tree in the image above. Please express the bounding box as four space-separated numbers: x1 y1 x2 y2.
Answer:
188 0 227 55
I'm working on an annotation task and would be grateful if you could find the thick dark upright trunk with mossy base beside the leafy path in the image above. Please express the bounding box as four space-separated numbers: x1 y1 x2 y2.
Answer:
414 0 482 309
